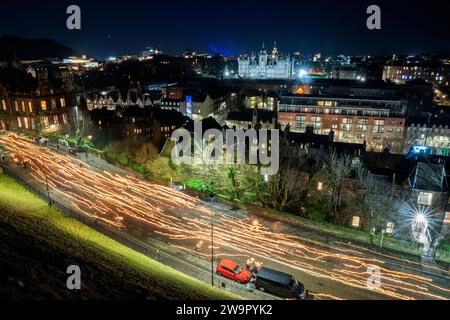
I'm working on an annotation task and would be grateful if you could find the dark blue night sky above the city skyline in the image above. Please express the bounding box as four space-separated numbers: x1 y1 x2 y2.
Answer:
0 0 450 58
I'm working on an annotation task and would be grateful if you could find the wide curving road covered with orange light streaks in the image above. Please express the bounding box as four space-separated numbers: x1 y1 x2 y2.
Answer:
0 135 450 299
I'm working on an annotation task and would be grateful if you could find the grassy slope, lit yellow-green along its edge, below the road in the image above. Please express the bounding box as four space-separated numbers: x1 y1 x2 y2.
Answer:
0 174 237 299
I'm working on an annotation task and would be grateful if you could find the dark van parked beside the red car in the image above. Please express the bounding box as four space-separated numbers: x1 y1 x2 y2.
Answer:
255 267 306 300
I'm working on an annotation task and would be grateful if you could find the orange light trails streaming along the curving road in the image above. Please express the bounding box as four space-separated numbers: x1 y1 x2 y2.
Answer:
0 135 450 299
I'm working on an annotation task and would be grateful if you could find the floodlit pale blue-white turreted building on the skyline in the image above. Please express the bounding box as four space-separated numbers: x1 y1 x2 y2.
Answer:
238 44 294 79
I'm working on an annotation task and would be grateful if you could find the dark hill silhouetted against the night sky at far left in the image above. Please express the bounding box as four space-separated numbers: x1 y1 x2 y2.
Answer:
0 36 77 61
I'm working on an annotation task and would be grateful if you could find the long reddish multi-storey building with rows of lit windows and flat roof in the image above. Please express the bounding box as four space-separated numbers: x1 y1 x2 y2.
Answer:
278 95 406 153
